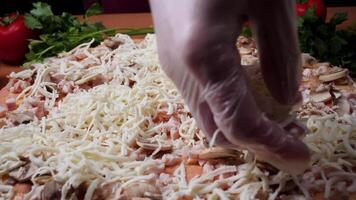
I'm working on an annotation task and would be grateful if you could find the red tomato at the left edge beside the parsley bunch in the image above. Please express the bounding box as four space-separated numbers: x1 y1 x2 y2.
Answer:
0 13 36 64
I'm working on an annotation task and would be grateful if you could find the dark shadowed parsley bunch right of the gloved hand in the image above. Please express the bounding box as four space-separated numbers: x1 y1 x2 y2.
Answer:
298 7 356 75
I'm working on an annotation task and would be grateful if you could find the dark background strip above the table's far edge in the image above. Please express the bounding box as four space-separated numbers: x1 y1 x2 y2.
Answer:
0 0 356 15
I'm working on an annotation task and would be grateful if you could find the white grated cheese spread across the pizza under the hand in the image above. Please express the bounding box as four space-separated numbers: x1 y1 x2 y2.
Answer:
0 34 356 200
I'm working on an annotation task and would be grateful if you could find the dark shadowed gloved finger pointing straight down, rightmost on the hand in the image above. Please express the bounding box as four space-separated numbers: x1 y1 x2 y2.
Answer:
249 0 301 105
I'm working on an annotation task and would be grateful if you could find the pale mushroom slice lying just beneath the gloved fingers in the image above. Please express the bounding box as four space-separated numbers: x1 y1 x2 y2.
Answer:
198 147 242 160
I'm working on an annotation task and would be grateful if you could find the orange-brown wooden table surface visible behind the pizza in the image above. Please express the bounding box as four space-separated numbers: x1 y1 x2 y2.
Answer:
0 7 356 88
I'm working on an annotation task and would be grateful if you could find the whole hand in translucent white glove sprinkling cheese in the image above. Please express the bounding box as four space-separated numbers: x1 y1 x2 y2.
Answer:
150 0 310 174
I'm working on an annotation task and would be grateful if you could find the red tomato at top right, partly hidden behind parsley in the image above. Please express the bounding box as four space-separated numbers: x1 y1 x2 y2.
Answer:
296 0 326 20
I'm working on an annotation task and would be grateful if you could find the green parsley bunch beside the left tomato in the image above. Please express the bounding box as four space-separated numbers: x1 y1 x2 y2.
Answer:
25 2 116 62
